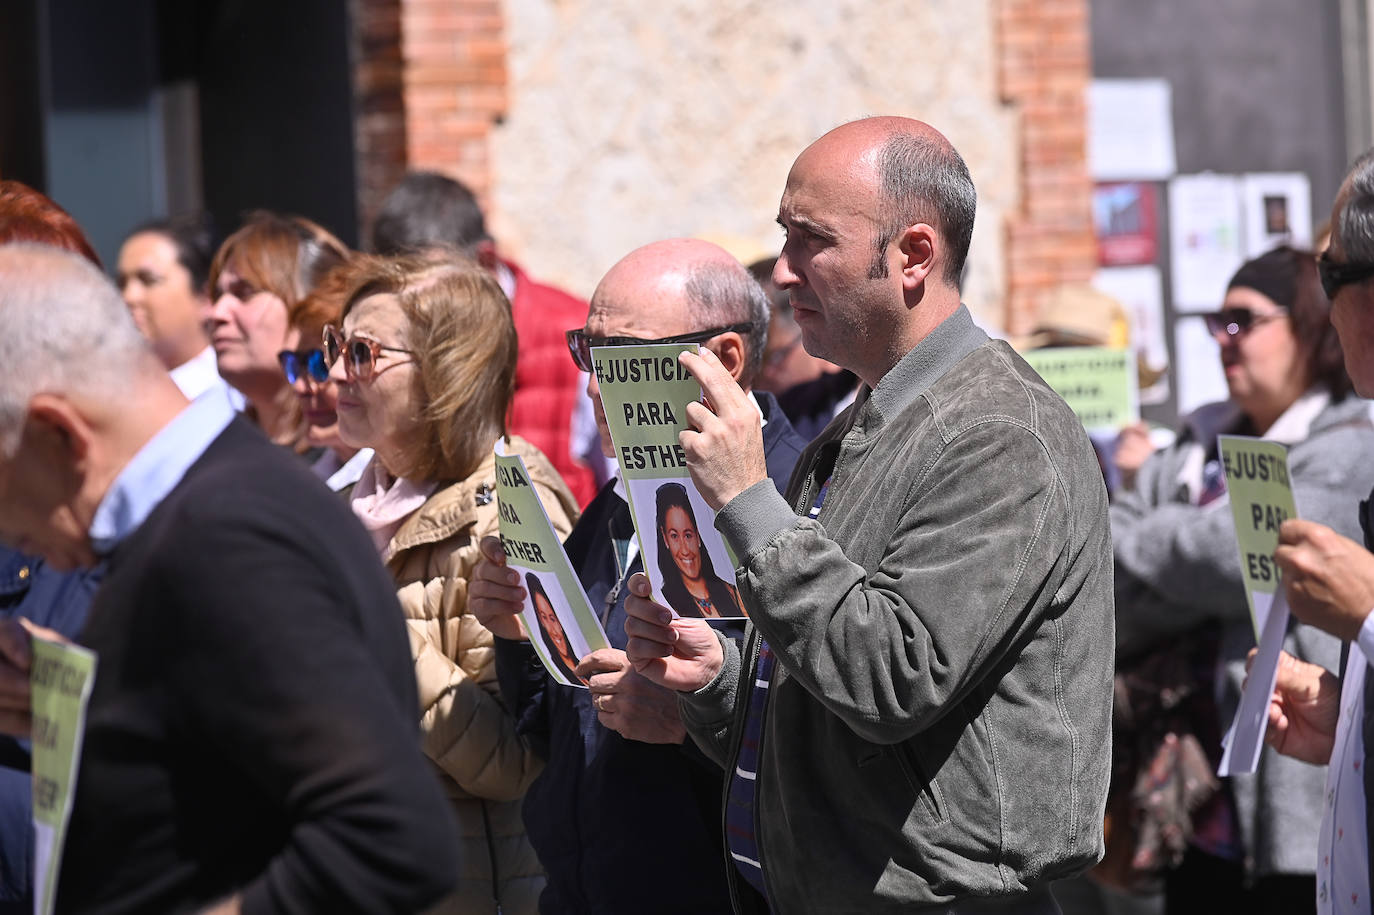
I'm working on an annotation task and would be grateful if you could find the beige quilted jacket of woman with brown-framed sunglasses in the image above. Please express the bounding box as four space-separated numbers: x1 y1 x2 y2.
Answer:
386 437 577 915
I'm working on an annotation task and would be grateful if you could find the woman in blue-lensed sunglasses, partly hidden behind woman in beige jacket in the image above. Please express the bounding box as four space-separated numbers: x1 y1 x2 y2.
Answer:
278 256 372 499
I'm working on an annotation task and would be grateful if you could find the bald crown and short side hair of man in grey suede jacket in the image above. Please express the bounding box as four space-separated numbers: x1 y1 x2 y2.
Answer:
793 117 978 287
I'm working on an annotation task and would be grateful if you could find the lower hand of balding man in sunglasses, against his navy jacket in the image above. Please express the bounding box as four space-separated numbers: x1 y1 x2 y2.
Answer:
577 648 687 743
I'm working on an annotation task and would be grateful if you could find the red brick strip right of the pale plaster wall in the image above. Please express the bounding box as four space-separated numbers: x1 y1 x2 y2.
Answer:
996 0 1096 334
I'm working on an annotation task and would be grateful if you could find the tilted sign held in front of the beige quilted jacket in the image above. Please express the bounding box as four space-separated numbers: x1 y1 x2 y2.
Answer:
496 441 610 688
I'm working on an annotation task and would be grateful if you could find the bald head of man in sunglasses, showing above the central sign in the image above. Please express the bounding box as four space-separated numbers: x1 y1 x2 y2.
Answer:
591 238 768 387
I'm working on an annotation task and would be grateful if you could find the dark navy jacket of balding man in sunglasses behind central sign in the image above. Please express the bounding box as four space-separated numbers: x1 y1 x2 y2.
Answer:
496 392 807 915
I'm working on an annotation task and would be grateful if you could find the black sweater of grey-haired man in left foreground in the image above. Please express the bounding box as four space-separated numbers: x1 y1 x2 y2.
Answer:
56 419 458 912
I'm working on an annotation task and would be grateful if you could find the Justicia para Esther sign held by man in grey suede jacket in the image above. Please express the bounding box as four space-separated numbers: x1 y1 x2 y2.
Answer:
592 343 745 618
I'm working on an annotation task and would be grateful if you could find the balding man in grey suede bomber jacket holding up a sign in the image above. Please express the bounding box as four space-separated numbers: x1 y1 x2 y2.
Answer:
625 117 1113 915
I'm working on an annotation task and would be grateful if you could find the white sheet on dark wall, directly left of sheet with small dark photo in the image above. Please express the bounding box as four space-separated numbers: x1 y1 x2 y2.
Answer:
1169 173 1245 311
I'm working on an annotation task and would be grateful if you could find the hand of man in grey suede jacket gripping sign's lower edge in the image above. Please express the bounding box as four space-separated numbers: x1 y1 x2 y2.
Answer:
625 572 724 692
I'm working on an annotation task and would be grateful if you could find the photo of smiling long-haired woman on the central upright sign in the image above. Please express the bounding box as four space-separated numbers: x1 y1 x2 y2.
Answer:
655 482 745 617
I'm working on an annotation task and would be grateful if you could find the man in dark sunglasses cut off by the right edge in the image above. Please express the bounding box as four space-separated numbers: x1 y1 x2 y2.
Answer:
1265 150 1374 912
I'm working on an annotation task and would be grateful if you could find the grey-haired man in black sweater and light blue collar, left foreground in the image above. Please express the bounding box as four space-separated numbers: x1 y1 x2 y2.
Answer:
0 245 458 914
